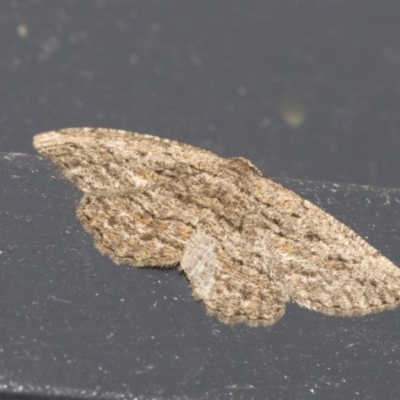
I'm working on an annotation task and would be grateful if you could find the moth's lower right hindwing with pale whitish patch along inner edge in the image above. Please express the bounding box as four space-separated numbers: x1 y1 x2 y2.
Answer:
180 211 288 326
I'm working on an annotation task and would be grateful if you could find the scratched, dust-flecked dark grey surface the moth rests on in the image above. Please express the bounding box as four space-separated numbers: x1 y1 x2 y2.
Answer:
0 155 400 399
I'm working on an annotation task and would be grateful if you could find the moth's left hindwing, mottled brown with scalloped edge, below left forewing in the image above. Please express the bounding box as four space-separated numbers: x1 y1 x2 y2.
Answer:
77 191 194 267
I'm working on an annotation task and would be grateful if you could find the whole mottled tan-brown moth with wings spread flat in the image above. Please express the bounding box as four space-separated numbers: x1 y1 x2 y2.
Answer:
34 128 400 325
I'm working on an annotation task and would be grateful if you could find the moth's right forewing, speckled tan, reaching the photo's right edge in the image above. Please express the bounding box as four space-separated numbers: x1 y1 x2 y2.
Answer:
255 179 400 316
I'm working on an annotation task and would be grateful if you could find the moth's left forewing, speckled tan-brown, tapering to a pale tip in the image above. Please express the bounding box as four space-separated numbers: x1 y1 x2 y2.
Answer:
33 128 223 192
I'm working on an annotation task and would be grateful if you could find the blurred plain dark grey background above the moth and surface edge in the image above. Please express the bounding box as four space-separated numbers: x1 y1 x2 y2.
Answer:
0 0 400 186
